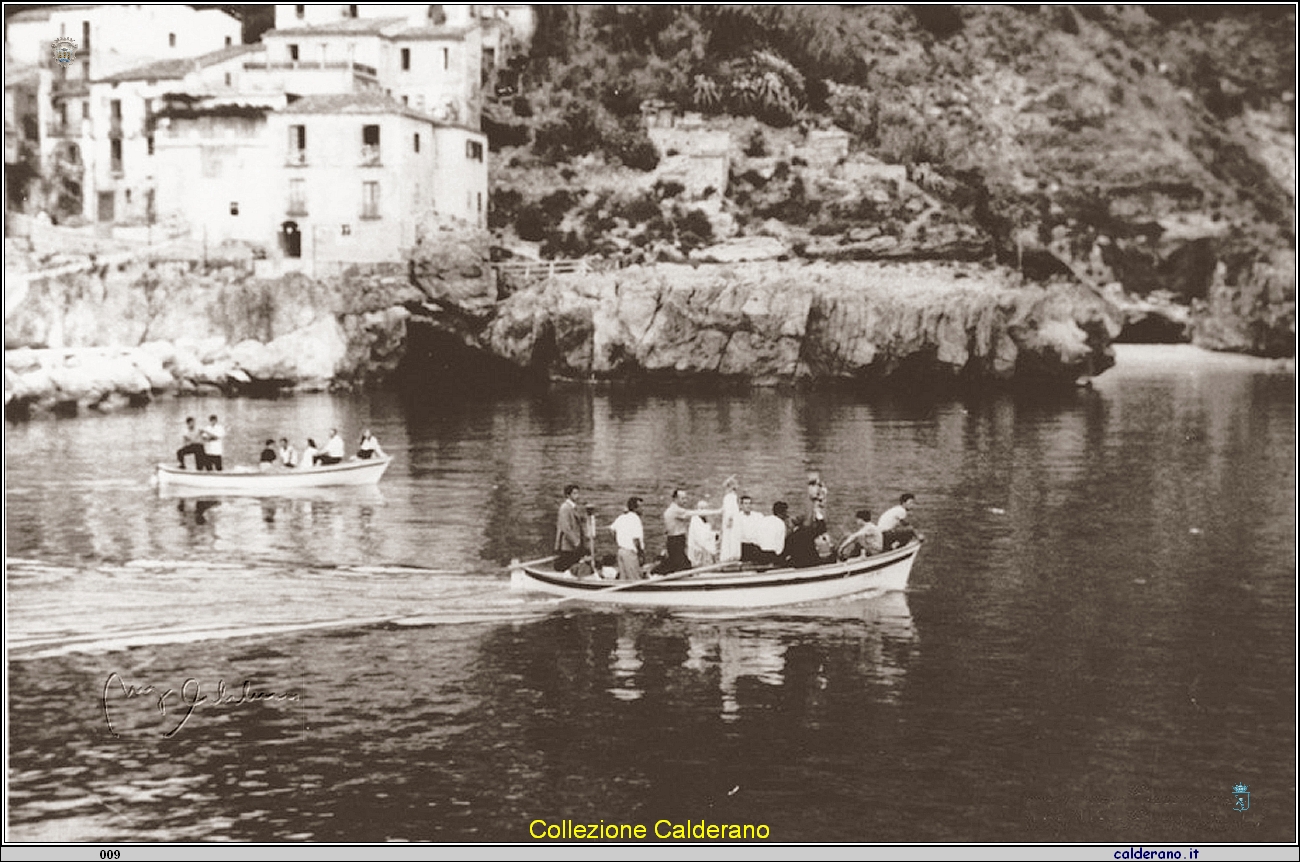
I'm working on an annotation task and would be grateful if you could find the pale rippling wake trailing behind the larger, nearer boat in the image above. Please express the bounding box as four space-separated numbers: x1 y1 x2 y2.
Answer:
5 558 553 660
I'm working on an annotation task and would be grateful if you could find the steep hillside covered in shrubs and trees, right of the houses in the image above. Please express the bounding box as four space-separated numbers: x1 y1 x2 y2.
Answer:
485 5 1295 355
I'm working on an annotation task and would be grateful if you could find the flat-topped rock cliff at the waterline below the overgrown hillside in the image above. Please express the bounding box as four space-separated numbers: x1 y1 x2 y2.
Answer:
413 261 1121 385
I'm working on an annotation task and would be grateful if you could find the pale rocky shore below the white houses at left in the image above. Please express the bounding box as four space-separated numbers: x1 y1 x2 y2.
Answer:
5 256 421 416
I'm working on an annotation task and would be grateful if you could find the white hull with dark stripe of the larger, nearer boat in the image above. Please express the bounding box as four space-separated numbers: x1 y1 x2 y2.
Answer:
510 541 920 608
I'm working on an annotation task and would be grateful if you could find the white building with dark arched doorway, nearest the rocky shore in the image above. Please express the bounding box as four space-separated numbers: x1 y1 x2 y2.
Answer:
157 91 488 274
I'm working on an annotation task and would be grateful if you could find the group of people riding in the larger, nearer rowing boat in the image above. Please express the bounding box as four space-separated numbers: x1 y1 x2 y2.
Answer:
555 472 922 580
